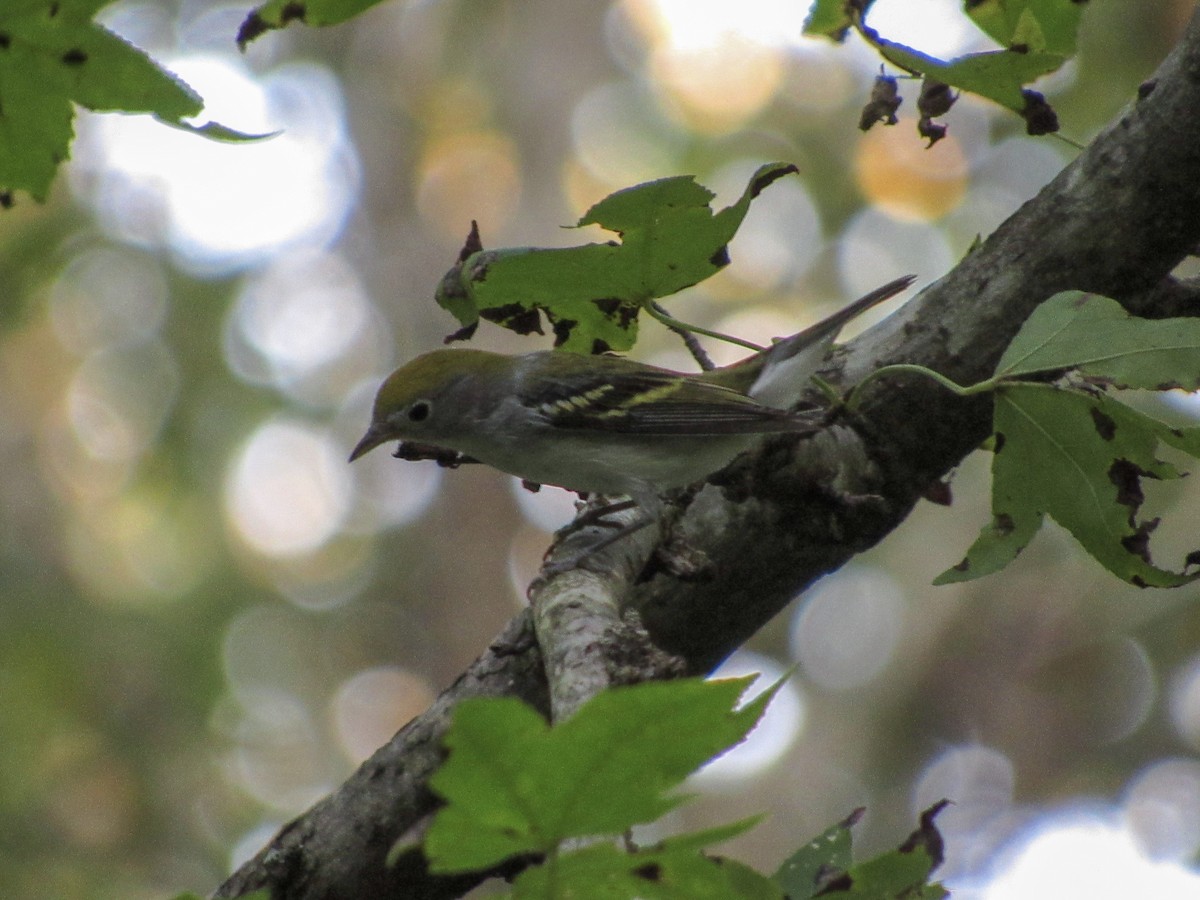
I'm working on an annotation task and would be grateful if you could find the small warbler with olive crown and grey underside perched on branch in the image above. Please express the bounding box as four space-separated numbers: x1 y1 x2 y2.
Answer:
350 276 916 518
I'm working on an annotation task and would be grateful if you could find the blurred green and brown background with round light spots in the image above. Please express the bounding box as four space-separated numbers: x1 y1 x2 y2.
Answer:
7 0 1200 900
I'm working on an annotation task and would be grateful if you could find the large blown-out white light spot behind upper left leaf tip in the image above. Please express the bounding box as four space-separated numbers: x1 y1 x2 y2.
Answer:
72 54 359 275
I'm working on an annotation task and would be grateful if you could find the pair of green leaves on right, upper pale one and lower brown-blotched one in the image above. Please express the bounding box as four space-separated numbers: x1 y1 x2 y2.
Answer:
935 292 1200 587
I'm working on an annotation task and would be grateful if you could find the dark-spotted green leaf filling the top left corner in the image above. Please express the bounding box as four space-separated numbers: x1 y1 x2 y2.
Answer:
0 0 202 200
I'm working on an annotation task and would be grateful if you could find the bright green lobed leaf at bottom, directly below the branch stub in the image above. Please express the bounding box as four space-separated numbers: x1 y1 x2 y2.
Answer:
425 678 778 871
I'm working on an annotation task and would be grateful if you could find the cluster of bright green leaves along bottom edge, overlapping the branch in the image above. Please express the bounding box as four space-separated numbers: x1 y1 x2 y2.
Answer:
422 676 943 900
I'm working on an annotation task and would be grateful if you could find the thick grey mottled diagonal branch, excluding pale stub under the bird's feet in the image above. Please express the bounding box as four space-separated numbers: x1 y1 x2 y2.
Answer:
218 16 1200 900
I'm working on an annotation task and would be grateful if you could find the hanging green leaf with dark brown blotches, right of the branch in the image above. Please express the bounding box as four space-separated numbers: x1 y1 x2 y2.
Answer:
935 382 1200 587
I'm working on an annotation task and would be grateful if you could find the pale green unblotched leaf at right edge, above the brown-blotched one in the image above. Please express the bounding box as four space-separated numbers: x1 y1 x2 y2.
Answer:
996 290 1200 390
